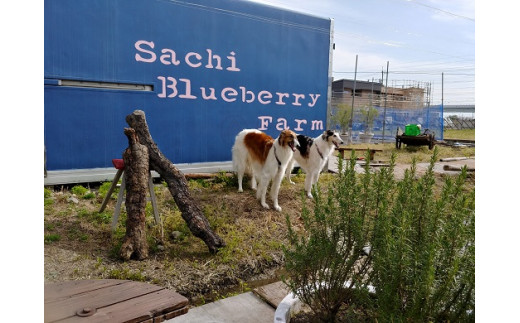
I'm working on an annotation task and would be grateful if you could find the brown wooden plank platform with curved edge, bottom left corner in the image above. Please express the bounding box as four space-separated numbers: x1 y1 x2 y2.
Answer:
44 279 188 323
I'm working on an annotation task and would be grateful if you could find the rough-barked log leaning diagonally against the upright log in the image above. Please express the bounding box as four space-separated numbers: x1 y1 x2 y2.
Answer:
126 110 226 253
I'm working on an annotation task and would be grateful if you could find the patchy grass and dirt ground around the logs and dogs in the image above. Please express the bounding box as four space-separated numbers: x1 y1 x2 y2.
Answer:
44 154 474 306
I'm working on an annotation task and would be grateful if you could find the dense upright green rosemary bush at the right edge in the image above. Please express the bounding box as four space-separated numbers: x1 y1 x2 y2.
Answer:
373 150 475 322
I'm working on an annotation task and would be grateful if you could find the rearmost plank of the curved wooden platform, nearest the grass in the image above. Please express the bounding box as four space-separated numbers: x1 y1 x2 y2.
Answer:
44 279 129 303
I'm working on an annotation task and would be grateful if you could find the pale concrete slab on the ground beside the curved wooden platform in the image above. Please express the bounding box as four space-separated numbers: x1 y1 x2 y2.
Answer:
165 292 275 323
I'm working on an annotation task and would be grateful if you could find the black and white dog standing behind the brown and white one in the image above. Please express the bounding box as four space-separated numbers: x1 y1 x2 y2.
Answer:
286 130 343 198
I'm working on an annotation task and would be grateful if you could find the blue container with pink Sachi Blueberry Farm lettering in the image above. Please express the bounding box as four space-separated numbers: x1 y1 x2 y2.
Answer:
44 0 332 184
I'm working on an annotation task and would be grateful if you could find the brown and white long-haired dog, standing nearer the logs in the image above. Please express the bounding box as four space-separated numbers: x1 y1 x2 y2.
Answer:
231 129 298 211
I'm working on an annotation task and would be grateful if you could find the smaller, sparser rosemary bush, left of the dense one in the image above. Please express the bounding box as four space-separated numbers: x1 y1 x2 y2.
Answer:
283 153 395 322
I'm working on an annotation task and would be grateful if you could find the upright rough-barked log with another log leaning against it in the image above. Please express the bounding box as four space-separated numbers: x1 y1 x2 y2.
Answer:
120 128 150 260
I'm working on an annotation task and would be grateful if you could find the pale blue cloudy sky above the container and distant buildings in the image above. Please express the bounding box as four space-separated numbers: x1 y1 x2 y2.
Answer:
253 0 475 105
